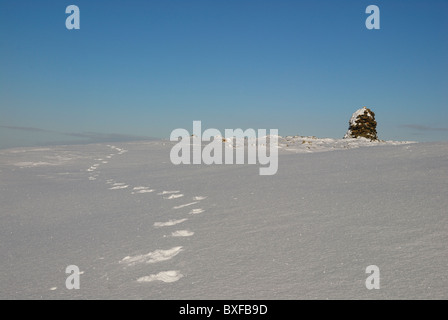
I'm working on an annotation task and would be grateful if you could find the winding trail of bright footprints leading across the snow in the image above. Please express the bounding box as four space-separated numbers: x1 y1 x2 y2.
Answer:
87 145 207 283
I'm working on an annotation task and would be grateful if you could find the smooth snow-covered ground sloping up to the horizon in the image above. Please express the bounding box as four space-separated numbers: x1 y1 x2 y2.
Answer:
0 136 448 299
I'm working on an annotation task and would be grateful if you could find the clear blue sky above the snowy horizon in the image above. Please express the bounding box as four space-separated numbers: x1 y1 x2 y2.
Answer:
0 0 448 148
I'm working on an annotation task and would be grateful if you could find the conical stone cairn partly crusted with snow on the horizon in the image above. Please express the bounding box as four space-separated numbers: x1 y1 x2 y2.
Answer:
344 107 378 140
